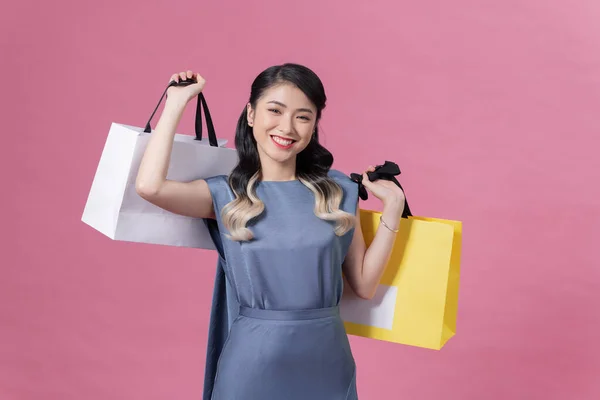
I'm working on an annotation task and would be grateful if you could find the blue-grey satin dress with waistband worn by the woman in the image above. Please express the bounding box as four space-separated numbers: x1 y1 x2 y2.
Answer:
203 170 358 400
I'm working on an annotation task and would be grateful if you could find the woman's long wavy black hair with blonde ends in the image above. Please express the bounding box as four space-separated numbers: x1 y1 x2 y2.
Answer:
222 63 354 241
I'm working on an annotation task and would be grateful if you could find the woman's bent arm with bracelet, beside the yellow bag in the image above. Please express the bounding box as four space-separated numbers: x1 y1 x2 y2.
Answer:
342 166 405 299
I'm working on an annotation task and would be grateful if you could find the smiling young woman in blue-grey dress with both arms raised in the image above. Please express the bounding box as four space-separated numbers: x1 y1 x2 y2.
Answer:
136 64 404 400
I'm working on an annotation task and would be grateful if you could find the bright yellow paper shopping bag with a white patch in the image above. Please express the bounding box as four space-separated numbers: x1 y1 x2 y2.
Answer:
341 209 462 350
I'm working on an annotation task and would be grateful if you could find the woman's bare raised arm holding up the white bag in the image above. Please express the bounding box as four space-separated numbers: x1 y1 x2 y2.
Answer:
135 71 215 222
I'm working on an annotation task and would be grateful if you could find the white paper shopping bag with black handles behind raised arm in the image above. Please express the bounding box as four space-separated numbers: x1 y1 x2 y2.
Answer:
82 84 238 249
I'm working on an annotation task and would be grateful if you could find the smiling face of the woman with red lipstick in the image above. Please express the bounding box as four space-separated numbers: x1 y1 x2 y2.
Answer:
247 83 317 163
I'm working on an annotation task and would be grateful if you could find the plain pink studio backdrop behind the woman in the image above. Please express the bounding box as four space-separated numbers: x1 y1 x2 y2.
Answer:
0 0 600 400
